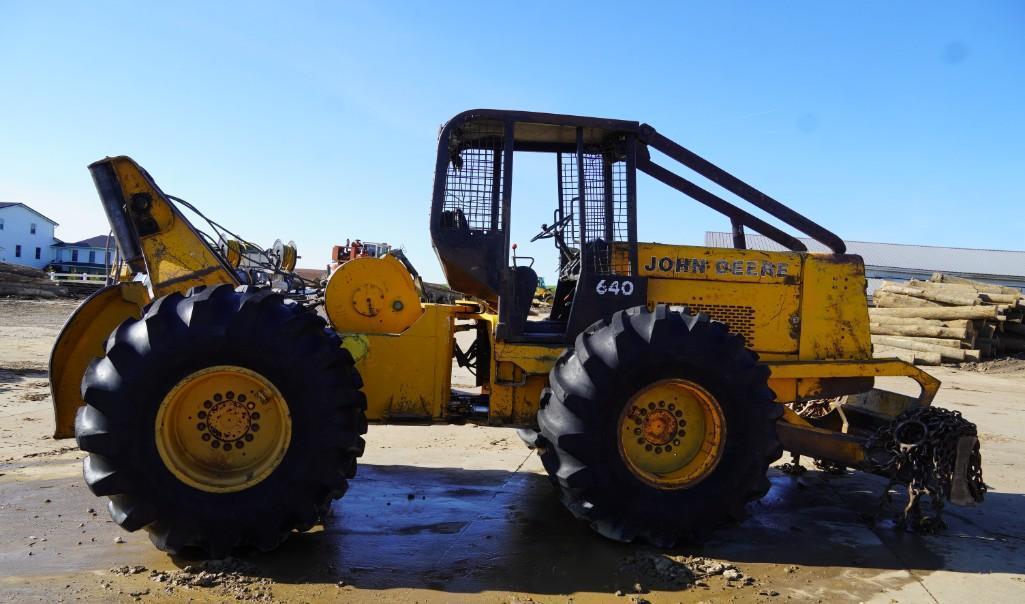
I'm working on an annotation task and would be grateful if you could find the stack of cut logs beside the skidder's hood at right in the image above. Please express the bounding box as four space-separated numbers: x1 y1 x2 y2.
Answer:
868 273 1025 365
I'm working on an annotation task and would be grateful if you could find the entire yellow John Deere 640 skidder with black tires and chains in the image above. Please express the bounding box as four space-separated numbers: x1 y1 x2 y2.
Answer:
51 110 985 556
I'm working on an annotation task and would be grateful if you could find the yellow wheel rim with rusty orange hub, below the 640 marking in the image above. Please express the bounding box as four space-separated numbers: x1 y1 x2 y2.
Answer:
618 379 726 489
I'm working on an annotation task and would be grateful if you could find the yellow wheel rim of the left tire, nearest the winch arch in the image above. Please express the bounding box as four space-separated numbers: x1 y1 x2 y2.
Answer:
156 365 292 493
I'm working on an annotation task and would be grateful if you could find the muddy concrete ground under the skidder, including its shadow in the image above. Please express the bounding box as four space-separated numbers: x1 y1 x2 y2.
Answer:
0 299 1025 602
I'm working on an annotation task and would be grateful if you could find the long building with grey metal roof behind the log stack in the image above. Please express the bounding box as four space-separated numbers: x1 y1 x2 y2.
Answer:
705 232 1025 293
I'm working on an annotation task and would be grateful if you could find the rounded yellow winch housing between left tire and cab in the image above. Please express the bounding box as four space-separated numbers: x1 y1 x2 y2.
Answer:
324 254 423 333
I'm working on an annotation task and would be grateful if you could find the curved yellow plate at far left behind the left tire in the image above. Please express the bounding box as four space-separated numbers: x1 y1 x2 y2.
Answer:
50 281 150 438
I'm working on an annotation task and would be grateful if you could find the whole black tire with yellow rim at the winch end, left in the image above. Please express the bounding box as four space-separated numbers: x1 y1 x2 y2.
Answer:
75 285 367 558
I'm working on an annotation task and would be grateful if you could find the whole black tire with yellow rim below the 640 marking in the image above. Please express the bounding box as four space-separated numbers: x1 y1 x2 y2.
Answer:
538 305 783 547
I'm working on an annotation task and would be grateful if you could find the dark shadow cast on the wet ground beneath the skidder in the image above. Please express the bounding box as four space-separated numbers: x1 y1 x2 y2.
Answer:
176 466 1025 594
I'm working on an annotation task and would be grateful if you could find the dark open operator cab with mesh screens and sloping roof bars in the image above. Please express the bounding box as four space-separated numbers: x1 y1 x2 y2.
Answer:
431 110 845 344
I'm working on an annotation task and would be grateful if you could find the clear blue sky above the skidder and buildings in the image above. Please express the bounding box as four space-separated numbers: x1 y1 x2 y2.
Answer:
0 0 1025 279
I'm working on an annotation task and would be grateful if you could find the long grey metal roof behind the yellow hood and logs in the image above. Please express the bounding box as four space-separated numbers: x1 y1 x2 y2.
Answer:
705 232 1025 277
